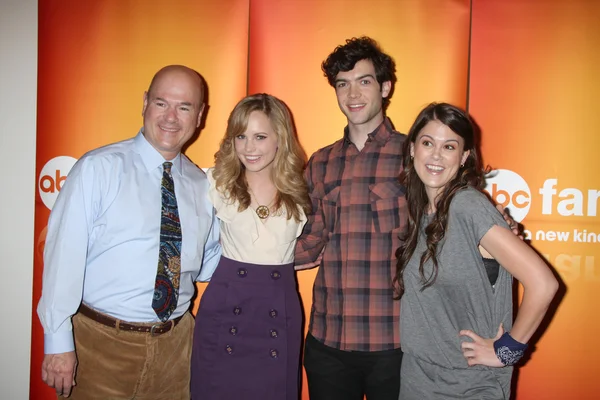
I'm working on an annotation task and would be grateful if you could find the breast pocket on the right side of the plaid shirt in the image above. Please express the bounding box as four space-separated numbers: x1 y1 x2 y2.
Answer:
369 180 406 233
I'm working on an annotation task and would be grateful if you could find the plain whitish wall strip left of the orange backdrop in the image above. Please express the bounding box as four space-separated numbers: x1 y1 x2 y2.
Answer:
0 0 38 400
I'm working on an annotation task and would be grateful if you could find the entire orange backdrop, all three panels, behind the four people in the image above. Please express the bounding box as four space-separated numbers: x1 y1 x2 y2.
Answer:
31 0 600 400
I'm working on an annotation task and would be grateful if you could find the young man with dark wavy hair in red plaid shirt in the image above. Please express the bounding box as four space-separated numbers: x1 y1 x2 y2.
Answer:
296 37 407 400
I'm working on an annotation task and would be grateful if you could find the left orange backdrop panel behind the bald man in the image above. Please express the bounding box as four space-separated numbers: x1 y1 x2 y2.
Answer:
30 0 249 400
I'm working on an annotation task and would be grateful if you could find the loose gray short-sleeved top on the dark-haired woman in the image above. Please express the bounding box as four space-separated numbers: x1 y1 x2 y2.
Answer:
400 188 512 372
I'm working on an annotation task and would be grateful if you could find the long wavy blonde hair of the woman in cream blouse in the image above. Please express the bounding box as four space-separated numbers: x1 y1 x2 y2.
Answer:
213 93 311 221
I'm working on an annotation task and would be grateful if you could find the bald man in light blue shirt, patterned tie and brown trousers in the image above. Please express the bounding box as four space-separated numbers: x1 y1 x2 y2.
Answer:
38 65 220 399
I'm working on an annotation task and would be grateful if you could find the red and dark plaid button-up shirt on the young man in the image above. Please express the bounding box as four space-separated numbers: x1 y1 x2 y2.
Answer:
295 119 408 351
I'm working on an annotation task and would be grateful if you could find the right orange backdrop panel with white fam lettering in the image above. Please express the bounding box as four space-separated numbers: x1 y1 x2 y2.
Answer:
469 0 600 400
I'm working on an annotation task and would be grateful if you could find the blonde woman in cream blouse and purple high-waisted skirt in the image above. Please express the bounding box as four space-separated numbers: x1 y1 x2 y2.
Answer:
191 94 310 400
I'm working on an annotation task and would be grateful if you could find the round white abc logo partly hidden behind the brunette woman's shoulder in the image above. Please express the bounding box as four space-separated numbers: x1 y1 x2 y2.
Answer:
485 169 531 222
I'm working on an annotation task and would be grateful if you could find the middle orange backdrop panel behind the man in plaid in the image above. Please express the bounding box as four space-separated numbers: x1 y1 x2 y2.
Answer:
248 0 469 399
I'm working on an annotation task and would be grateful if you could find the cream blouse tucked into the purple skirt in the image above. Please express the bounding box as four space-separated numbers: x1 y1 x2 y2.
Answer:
206 168 306 265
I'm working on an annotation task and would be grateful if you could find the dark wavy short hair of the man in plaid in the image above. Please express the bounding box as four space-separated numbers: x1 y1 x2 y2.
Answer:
321 36 396 106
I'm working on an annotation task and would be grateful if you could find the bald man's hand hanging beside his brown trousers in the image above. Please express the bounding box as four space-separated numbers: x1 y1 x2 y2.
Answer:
42 351 77 397
